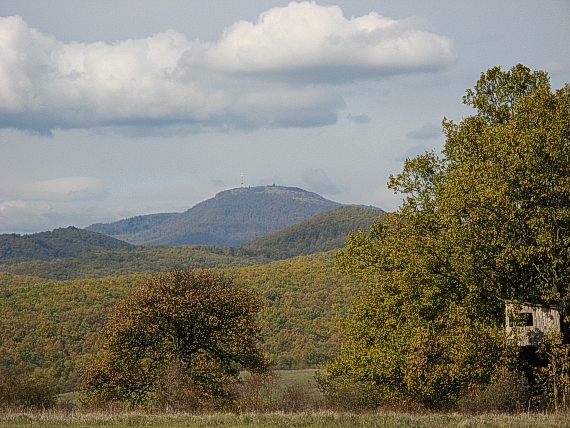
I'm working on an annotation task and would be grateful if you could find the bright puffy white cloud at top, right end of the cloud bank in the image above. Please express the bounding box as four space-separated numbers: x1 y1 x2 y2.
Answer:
205 2 454 81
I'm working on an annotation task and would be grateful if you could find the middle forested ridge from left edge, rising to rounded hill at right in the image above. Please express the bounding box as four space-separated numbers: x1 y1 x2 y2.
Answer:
0 206 374 280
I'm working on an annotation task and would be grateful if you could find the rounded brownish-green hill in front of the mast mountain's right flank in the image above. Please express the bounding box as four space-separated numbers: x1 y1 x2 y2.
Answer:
237 205 386 260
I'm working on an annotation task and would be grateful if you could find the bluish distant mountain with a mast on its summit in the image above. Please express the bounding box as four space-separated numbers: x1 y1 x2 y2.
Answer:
87 186 341 246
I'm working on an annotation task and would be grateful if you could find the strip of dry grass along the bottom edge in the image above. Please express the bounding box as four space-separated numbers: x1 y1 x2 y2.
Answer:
0 413 570 428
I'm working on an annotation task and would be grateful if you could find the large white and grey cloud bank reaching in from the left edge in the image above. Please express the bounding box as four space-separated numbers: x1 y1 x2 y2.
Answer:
0 2 454 134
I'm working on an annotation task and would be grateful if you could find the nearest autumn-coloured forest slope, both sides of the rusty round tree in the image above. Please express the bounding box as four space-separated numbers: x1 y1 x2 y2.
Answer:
0 252 359 390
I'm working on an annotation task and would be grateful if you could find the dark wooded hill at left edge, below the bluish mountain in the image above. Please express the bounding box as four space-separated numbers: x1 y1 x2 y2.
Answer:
0 227 133 264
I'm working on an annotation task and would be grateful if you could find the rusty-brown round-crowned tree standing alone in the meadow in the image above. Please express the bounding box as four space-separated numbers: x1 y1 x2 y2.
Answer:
82 270 267 405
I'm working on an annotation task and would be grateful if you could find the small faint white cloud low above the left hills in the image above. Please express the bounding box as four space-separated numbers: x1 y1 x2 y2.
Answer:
16 177 105 202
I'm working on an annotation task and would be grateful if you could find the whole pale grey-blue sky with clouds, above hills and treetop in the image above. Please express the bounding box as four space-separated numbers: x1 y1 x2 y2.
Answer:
0 0 570 234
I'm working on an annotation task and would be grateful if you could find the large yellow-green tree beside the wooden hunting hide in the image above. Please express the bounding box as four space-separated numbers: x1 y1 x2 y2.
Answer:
329 64 570 408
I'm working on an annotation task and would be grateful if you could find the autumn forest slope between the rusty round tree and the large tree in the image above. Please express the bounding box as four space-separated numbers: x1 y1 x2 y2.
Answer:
231 252 361 368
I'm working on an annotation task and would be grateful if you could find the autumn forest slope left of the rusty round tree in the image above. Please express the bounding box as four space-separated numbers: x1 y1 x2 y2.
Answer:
0 273 141 392
